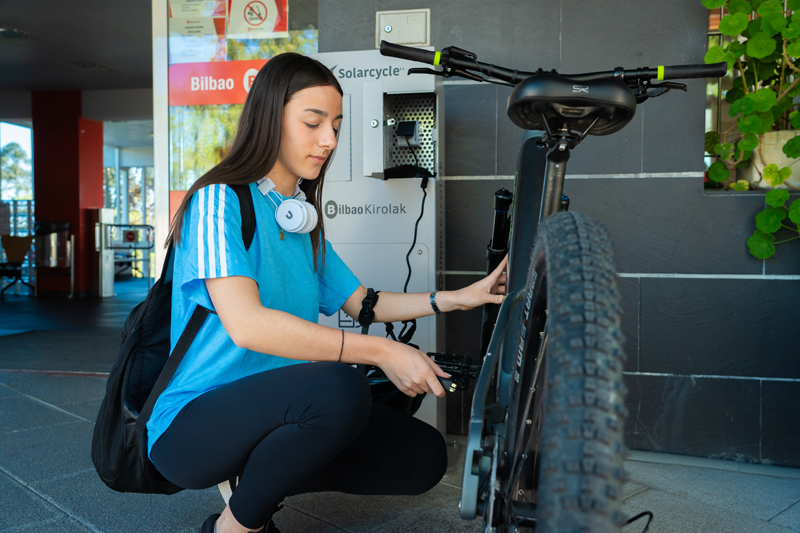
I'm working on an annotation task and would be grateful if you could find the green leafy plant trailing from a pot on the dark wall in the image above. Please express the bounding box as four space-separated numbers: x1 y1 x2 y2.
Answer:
702 0 800 259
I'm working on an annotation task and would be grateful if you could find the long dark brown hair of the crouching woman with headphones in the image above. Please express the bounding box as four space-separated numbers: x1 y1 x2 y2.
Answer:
166 52 343 270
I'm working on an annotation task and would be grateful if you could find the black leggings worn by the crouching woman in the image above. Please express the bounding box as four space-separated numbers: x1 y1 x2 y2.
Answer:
150 363 447 529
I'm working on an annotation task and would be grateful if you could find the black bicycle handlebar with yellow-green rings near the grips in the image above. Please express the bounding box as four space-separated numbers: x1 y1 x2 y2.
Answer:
380 41 728 85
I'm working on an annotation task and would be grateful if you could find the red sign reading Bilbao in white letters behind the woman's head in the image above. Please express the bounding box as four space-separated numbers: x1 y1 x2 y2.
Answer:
169 59 267 106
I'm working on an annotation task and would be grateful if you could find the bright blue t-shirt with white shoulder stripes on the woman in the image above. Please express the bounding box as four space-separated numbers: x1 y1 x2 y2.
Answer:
147 183 360 453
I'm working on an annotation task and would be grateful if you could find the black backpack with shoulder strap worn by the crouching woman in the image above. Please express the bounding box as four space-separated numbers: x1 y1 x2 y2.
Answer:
92 185 256 494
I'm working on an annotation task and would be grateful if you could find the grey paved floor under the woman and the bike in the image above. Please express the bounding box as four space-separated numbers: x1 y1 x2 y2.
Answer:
0 286 800 533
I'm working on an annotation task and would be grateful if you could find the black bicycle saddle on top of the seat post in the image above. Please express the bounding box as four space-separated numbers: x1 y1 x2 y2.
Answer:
508 73 636 135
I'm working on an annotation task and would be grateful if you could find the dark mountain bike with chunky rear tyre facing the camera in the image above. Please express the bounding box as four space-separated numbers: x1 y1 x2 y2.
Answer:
380 41 727 533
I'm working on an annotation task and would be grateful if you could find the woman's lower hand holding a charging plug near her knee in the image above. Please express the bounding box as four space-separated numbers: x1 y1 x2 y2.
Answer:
378 341 450 397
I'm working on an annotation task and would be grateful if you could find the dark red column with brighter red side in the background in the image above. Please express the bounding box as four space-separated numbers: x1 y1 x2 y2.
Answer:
31 91 103 295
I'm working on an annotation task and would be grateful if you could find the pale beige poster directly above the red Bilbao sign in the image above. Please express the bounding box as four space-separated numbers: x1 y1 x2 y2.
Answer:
168 0 227 64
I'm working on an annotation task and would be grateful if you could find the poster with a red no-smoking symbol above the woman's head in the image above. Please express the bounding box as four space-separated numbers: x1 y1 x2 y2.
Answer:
228 0 289 39
